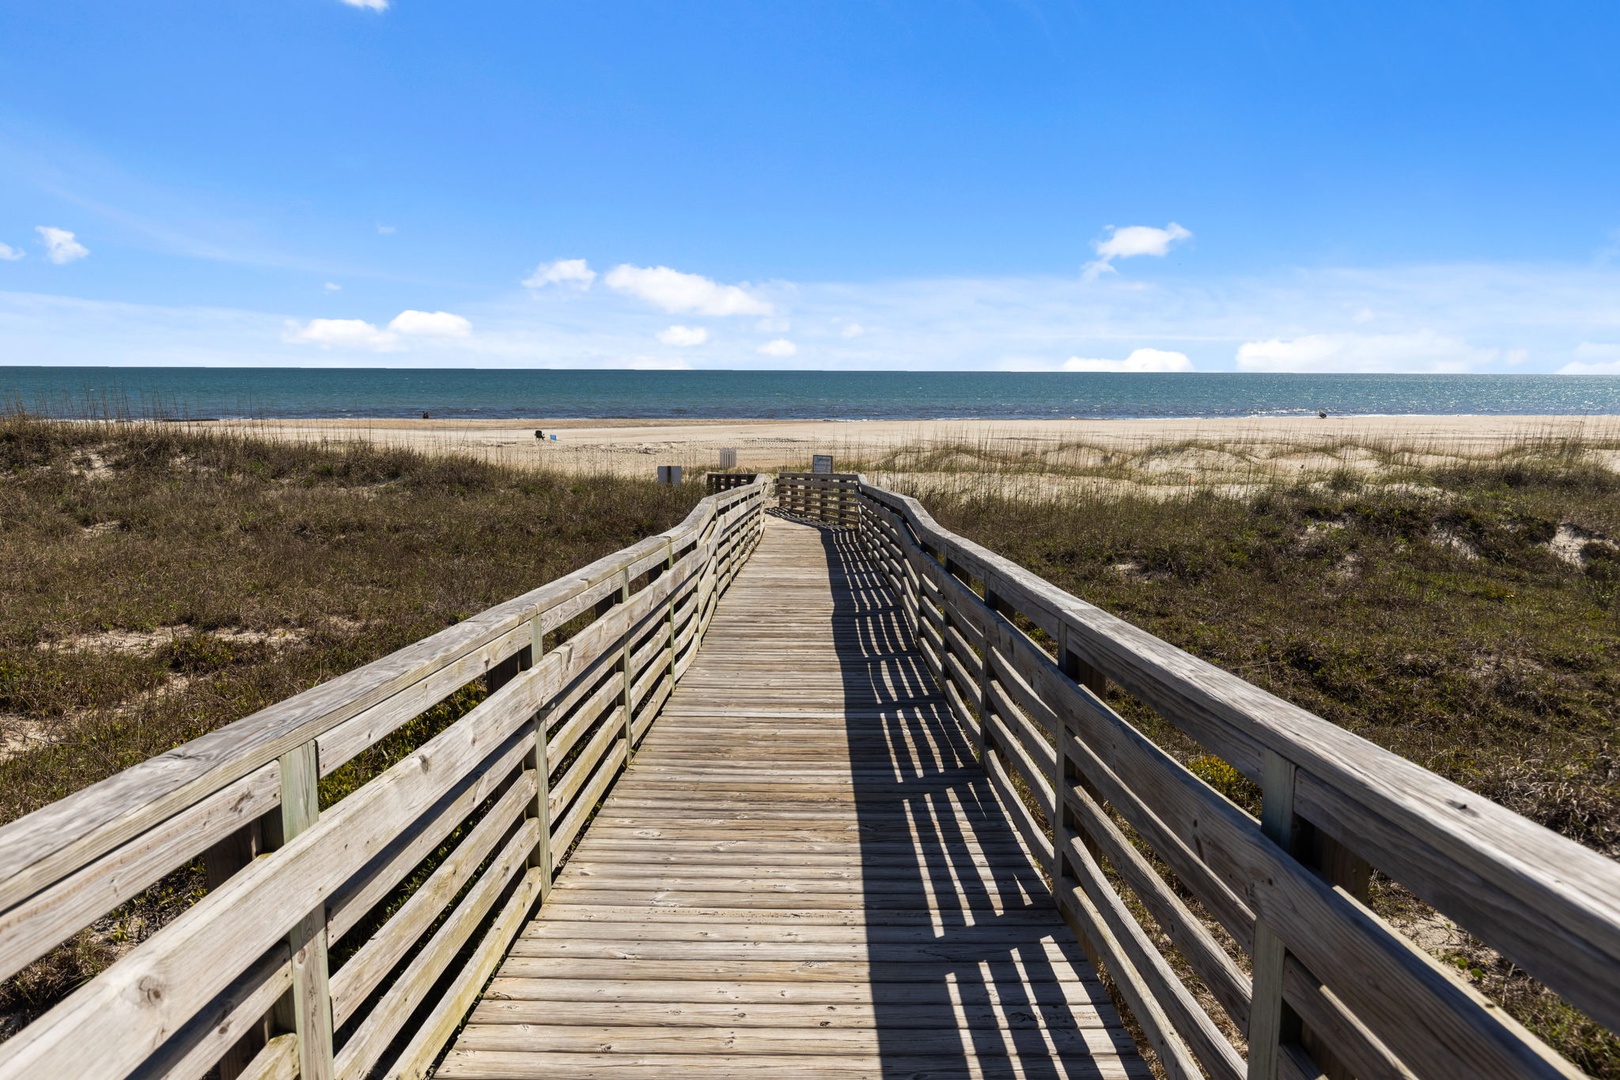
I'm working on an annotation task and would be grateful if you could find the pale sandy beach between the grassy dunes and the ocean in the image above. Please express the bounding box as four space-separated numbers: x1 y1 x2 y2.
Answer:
211 416 1620 479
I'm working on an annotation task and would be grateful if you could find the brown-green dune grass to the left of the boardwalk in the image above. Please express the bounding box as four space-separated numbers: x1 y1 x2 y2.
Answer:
0 415 703 1038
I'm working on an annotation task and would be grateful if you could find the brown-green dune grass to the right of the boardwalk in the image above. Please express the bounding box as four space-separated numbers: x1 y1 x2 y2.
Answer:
885 445 1620 1077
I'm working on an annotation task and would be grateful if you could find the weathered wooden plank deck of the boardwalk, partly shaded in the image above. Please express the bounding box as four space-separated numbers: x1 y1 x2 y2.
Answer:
437 518 1149 1080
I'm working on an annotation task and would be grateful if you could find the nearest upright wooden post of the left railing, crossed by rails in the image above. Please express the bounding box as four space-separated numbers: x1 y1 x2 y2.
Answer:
267 740 332 1080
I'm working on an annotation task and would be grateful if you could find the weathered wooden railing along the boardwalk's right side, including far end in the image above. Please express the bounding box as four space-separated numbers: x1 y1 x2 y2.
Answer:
778 473 1620 1080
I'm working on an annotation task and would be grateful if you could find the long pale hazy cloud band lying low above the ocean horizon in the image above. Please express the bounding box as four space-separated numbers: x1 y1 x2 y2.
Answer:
12 253 1620 372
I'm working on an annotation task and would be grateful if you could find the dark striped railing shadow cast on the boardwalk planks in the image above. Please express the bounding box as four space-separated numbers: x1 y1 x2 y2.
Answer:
821 526 1134 1080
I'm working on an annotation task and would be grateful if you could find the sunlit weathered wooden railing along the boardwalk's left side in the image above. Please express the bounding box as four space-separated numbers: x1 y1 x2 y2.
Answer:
0 478 768 1080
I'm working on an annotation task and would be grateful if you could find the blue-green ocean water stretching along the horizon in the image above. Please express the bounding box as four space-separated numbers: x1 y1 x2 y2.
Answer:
0 368 1620 419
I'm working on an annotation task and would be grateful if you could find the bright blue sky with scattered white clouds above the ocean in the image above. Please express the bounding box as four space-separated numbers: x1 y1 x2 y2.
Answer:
0 0 1620 379
